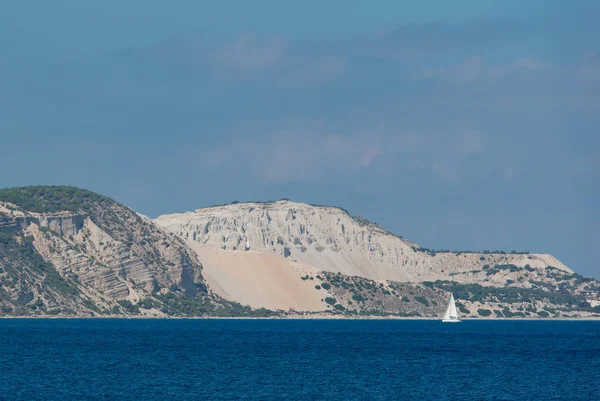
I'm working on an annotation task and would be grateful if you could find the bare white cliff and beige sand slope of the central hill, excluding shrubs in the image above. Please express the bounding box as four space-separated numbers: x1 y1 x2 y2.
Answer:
154 201 571 311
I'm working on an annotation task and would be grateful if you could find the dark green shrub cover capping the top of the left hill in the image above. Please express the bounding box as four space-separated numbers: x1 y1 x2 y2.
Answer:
0 186 114 213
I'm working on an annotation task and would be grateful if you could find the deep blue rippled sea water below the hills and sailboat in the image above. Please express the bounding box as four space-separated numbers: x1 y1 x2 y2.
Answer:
0 319 600 401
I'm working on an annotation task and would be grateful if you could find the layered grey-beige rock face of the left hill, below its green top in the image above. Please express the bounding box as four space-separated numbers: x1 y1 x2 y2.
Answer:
0 198 202 302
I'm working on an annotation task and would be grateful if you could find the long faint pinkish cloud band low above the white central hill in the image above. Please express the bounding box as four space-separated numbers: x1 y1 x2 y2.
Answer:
200 131 486 182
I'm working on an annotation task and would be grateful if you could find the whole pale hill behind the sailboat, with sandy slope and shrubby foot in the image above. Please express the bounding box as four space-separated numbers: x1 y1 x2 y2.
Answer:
155 200 600 317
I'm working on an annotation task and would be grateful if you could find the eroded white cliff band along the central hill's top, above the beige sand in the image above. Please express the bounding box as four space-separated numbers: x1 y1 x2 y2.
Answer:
155 201 571 285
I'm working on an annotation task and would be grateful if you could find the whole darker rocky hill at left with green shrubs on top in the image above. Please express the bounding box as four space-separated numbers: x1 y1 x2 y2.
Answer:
0 187 270 316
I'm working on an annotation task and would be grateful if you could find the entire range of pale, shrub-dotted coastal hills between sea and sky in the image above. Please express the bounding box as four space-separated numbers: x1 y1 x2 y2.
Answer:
0 186 600 318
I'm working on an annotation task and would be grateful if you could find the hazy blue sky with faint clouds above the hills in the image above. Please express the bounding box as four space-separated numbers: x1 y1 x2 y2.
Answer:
0 0 600 278
